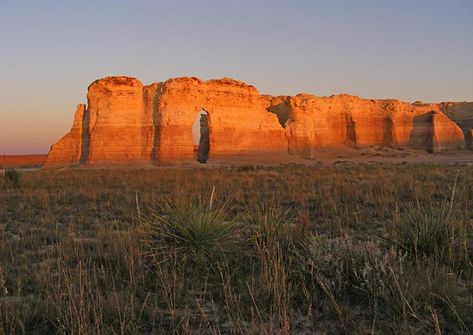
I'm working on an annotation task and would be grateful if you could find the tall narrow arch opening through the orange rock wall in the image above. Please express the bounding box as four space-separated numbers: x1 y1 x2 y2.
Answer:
192 109 210 163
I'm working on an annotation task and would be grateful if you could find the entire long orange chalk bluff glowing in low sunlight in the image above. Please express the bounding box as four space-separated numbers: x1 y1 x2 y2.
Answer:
45 76 473 167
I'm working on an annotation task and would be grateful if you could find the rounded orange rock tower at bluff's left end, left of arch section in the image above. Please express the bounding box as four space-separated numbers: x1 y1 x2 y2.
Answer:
84 77 153 164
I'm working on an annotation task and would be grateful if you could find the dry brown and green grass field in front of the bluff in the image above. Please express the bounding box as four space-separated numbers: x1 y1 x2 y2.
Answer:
0 164 473 334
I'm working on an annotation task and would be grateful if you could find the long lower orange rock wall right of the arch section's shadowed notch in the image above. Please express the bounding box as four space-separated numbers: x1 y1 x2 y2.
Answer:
270 94 465 158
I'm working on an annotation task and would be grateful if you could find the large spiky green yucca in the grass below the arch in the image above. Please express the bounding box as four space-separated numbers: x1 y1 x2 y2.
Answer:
146 199 241 267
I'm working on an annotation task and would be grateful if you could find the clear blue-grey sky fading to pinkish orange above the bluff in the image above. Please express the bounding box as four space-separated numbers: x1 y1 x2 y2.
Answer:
0 0 473 154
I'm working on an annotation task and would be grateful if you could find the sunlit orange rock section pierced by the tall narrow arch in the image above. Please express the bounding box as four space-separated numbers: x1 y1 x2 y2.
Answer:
156 78 287 160
